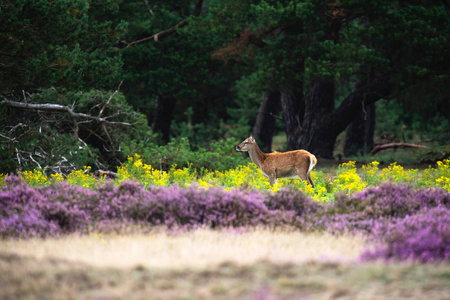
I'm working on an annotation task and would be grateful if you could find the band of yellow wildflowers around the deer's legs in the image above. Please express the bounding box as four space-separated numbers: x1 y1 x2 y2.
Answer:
8 154 450 203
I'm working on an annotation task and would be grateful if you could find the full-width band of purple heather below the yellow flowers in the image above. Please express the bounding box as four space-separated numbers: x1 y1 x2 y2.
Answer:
0 176 450 262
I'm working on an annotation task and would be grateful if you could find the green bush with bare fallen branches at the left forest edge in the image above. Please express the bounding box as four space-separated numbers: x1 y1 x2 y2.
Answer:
0 89 150 174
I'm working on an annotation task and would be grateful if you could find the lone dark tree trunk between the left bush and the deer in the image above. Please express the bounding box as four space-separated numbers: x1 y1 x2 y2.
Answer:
152 96 176 143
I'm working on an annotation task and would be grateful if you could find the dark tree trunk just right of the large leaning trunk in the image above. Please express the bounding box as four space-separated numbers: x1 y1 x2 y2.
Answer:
344 104 375 156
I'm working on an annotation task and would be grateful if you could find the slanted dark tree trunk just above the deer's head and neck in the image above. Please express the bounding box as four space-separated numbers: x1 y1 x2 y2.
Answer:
252 91 281 152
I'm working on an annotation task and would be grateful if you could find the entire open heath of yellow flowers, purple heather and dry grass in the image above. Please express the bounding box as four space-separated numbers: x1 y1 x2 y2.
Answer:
0 155 450 299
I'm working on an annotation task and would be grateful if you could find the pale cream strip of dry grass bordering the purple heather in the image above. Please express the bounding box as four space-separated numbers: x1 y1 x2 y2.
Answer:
0 228 364 270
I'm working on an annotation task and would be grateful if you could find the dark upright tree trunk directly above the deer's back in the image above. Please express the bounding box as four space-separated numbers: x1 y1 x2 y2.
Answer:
281 91 302 150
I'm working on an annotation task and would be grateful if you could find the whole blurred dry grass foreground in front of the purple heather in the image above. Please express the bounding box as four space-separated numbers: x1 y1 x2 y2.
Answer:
0 228 450 299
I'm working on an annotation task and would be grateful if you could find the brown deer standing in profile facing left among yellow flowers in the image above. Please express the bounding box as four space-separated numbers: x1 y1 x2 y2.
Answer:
235 136 317 188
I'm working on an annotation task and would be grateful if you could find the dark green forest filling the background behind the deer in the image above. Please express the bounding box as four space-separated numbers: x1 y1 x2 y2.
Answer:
0 0 450 174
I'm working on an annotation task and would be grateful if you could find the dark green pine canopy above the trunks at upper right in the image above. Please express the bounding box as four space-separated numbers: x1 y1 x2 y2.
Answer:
203 0 450 135
